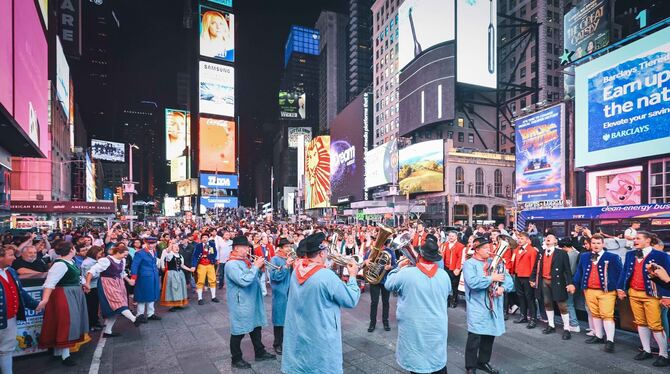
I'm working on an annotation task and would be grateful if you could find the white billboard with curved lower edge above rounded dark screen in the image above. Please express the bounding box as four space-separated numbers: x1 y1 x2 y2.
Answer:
398 0 455 69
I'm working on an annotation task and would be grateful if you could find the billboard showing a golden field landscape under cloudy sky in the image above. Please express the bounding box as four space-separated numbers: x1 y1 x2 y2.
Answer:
398 139 444 194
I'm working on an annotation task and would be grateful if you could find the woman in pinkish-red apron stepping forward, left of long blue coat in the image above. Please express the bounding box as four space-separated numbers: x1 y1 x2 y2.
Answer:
84 244 139 338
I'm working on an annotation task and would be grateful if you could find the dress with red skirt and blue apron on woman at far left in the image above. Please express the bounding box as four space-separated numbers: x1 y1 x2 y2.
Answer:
39 259 91 352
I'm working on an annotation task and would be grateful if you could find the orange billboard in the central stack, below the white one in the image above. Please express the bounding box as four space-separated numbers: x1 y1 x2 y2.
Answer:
198 116 236 173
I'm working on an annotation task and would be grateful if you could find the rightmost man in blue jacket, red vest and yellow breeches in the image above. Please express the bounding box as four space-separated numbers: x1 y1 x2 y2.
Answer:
617 231 670 367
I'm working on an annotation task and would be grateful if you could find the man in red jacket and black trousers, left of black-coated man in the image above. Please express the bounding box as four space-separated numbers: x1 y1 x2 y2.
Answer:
512 232 537 329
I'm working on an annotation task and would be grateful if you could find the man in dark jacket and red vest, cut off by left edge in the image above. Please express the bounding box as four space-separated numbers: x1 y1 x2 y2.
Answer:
0 244 38 374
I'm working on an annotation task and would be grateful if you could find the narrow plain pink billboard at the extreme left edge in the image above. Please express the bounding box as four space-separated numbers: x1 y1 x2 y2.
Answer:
0 0 14 115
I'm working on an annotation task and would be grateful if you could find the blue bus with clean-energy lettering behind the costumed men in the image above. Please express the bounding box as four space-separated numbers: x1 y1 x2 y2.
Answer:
517 203 670 250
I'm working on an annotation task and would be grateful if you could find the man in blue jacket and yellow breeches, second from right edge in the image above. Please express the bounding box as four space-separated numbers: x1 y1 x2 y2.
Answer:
568 234 623 353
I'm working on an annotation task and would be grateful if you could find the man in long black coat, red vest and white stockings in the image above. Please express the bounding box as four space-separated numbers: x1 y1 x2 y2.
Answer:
530 234 572 340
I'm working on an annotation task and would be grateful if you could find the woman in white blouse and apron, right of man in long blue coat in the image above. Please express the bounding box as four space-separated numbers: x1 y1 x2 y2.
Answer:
161 240 195 312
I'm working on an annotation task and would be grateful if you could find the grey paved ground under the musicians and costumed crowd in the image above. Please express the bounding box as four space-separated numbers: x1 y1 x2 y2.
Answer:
14 284 669 374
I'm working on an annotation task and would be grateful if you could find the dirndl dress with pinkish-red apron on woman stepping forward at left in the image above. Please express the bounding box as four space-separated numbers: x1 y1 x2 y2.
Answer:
98 256 128 318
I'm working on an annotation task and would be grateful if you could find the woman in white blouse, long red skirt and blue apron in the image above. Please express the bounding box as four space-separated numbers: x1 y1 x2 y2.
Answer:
37 242 91 366
